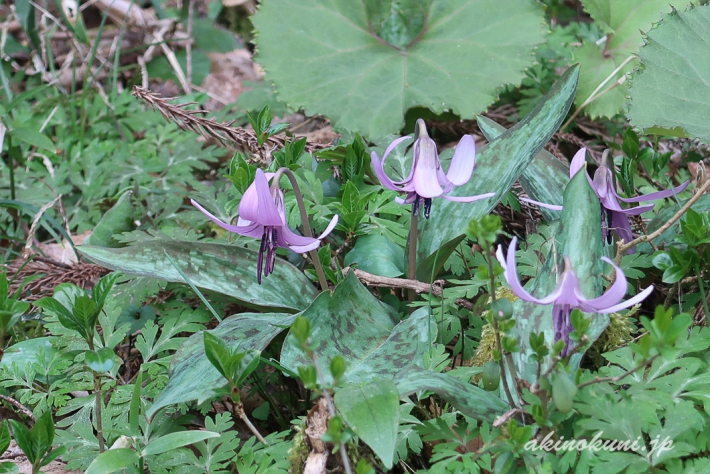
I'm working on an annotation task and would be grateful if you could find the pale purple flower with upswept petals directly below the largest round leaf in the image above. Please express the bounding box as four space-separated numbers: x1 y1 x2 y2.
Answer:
370 119 495 219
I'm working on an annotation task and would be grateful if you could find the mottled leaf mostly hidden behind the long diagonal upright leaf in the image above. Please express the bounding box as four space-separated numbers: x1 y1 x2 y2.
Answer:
477 115 569 222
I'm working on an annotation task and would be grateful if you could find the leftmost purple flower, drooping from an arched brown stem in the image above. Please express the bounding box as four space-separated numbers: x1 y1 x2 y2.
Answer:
190 169 338 284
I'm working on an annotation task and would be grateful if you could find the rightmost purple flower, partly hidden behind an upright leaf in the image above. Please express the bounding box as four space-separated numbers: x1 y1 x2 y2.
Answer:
569 148 690 248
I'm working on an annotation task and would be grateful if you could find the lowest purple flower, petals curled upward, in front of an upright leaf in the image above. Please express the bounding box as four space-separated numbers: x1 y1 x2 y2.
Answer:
496 237 653 357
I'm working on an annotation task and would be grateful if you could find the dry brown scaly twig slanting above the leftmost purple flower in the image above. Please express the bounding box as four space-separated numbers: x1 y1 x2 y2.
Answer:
133 86 330 155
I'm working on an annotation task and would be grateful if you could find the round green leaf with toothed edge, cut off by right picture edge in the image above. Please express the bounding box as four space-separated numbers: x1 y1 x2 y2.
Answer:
629 6 710 143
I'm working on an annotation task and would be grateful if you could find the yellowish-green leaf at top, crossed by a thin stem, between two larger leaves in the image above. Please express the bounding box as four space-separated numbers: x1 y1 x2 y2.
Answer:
573 0 688 118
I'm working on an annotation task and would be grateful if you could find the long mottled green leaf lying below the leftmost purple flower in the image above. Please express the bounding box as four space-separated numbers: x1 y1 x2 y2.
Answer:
77 238 317 312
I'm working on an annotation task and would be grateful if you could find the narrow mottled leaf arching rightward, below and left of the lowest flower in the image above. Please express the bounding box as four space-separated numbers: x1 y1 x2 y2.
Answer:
395 366 509 423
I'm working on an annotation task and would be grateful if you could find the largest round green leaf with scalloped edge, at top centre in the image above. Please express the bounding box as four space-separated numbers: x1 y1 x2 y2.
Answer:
252 0 545 137
